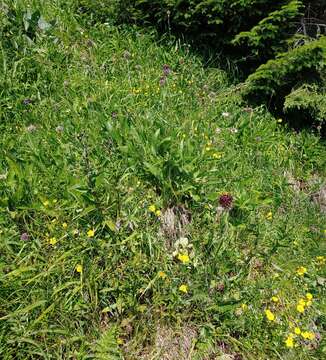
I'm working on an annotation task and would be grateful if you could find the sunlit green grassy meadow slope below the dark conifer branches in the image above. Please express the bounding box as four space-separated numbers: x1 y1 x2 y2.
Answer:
0 0 326 360
